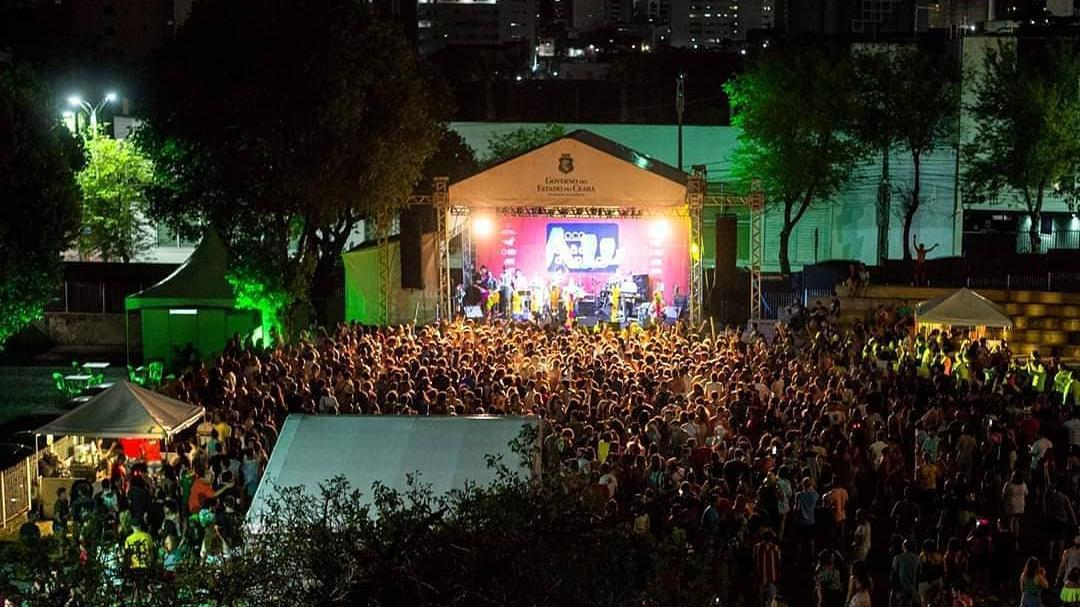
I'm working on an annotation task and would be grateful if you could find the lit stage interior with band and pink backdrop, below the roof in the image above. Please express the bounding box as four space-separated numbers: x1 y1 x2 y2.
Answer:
455 211 690 325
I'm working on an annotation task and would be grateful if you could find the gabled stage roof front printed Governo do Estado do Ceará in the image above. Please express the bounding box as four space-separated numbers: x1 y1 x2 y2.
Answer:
449 131 689 208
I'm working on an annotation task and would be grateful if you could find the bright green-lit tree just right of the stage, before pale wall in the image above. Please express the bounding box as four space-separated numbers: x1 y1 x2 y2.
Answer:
725 49 862 275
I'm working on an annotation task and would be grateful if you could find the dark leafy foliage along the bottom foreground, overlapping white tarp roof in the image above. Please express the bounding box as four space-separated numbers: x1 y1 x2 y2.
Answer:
0 427 717 607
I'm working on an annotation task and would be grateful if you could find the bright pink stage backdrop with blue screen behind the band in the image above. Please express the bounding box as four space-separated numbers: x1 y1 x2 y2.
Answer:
474 217 690 301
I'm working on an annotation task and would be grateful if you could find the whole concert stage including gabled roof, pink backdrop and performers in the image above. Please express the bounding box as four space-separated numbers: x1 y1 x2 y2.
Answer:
433 131 704 326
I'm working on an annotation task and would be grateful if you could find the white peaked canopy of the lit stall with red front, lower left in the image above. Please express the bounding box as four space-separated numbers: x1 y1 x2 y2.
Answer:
37 381 204 439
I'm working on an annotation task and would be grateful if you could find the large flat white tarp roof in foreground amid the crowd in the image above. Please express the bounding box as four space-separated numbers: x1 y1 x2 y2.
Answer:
247 415 536 529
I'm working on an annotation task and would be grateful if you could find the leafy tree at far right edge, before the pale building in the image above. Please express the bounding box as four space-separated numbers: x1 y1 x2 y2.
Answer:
963 43 1080 253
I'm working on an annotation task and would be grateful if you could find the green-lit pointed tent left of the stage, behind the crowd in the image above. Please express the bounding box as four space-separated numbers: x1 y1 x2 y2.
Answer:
124 230 260 368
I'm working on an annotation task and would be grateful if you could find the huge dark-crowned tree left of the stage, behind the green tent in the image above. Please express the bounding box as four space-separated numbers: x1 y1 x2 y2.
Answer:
138 0 445 328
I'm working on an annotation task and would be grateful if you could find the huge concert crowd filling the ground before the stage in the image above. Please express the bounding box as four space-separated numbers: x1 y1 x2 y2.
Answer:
14 295 1080 607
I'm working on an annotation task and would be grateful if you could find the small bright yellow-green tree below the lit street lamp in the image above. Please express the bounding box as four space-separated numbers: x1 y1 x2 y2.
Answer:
76 133 153 264
